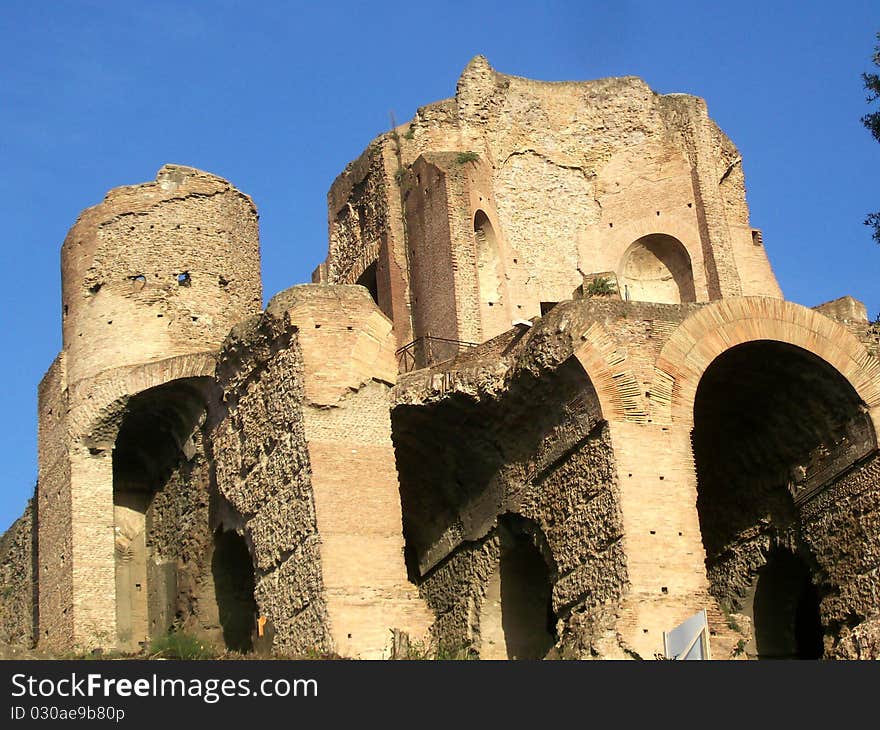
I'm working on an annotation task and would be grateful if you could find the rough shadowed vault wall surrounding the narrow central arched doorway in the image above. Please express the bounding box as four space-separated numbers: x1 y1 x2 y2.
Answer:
392 330 627 657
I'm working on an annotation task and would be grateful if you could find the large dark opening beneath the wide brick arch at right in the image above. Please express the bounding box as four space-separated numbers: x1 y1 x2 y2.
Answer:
693 340 876 656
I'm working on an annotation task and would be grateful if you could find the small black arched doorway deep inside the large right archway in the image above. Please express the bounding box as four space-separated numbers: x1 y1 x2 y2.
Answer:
753 548 823 659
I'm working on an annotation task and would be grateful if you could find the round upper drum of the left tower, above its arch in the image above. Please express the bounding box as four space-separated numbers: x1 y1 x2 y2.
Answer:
61 165 262 384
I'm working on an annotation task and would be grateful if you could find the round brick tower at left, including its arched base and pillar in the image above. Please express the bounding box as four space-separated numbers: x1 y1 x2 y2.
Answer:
38 165 262 650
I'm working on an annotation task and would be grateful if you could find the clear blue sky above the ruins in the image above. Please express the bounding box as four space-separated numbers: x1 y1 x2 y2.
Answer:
0 0 880 530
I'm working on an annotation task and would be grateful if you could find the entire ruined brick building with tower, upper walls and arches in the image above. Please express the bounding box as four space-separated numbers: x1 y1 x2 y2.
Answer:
0 57 880 658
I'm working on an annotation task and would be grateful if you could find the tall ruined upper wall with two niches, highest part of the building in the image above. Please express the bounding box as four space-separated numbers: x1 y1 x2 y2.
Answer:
316 56 781 350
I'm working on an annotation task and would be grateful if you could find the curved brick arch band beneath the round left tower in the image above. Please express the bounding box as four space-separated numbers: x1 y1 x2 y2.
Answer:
68 352 217 445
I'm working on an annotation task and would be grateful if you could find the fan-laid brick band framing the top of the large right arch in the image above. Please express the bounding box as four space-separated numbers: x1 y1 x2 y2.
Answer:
650 297 880 430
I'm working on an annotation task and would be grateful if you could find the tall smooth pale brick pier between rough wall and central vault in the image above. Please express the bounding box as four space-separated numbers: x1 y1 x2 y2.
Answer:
267 285 430 659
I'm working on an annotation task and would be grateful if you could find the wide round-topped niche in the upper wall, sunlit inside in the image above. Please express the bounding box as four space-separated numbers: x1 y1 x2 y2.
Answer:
619 233 697 304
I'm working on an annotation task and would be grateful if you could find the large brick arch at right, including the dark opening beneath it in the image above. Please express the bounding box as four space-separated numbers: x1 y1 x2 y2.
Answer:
668 298 878 658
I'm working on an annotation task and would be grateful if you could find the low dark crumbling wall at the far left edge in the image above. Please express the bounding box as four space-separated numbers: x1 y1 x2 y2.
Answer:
0 500 37 648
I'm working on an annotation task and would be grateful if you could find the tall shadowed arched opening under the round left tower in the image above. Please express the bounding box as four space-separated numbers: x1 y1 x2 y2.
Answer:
113 378 212 651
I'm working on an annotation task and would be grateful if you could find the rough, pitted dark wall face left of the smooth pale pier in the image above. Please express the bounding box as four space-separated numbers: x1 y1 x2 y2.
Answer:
212 314 331 654
